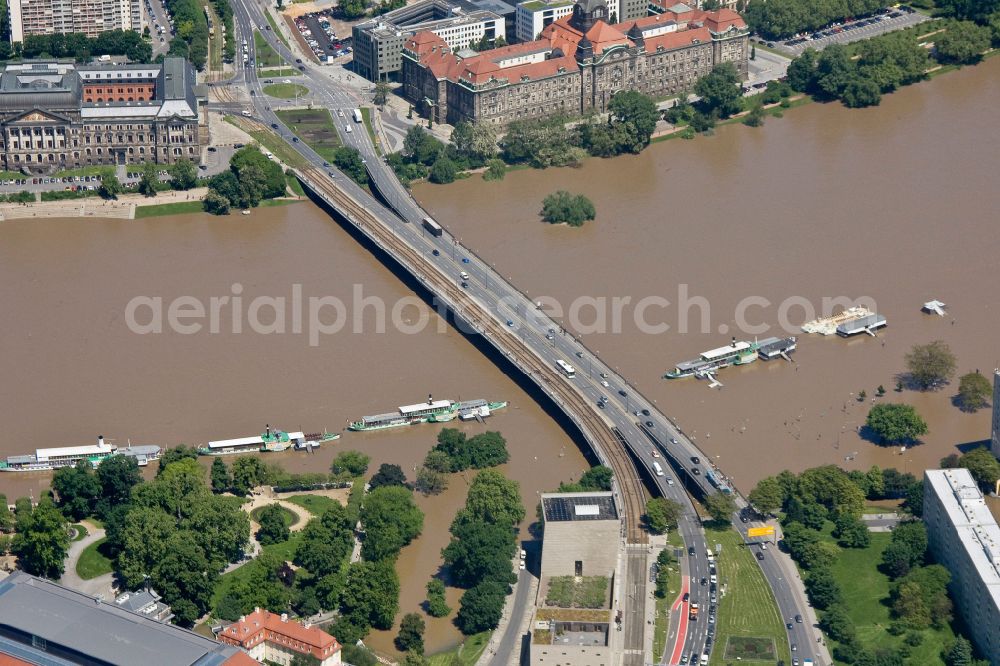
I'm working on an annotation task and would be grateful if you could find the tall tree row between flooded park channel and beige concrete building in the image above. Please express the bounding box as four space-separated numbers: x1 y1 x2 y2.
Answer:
444 470 524 635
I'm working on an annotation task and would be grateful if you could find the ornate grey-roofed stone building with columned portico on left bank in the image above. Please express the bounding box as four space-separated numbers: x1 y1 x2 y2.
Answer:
0 58 205 173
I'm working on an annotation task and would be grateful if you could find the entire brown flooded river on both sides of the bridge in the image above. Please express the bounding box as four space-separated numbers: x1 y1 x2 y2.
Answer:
0 59 1000 652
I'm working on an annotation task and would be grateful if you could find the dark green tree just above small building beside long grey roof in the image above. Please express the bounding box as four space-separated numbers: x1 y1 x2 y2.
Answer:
152 533 218 627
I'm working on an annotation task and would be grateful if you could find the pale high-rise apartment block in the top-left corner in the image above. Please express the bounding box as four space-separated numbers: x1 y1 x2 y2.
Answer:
8 0 143 43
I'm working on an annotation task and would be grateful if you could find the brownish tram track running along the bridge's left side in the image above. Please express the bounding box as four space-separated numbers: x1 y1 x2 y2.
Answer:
301 167 649 544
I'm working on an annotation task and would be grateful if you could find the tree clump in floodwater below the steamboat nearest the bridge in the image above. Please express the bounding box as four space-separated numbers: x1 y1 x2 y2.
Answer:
415 428 510 495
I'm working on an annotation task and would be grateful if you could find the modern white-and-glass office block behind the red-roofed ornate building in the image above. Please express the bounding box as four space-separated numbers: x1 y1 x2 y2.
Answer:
352 0 514 81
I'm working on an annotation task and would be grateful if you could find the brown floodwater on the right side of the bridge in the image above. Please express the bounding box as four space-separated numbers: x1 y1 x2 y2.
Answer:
415 58 1000 492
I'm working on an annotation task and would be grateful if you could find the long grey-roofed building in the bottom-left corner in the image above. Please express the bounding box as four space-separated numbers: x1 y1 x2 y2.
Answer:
0 571 254 666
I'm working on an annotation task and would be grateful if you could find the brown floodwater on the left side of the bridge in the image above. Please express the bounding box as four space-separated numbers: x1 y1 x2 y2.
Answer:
0 203 588 651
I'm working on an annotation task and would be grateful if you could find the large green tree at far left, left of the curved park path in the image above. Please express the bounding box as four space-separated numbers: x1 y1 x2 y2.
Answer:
10 498 69 579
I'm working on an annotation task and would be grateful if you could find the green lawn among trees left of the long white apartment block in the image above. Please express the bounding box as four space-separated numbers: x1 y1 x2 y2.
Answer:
823 524 955 664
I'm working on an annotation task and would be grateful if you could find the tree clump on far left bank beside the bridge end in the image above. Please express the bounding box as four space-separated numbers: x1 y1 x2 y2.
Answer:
203 145 286 215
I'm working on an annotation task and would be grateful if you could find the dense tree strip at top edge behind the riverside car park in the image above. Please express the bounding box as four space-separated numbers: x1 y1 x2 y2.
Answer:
743 0 891 39
